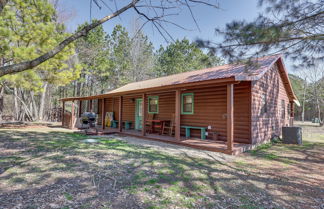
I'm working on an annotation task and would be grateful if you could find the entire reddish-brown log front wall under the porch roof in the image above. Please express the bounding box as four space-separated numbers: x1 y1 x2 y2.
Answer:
99 82 251 143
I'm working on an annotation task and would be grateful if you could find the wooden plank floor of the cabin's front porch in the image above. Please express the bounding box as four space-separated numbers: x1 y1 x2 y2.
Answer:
79 125 253 155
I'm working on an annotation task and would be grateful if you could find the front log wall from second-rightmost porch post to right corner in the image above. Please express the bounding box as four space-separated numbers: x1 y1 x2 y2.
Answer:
181 82 251 143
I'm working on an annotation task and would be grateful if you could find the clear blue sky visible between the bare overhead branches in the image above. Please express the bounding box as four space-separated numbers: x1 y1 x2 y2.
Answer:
61 0 291 71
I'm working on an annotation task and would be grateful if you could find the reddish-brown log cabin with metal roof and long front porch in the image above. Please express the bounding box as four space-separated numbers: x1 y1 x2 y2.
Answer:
62 55 298 154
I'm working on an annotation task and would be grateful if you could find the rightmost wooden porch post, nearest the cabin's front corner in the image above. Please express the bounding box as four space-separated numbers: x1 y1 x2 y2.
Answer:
227 84 234 152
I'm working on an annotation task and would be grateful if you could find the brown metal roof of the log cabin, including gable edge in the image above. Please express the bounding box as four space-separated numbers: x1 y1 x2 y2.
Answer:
62 55 295 101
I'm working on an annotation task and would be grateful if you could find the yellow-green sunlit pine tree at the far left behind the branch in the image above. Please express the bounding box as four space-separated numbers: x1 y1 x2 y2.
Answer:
0 0 80 120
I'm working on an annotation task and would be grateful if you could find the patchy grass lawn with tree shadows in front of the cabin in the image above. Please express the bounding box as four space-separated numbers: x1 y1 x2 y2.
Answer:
0 126 324 209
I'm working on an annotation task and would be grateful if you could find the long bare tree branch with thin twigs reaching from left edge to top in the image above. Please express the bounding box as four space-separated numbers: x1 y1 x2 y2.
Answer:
0 0 218 77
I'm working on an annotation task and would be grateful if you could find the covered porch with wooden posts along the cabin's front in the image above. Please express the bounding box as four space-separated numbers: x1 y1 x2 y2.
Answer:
62 82 251 154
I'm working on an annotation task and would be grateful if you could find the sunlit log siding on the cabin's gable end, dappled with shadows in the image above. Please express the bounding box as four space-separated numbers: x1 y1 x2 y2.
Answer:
251 64 289 144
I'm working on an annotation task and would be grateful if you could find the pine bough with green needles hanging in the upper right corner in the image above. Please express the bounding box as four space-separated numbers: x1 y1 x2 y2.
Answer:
197 0 324 67
